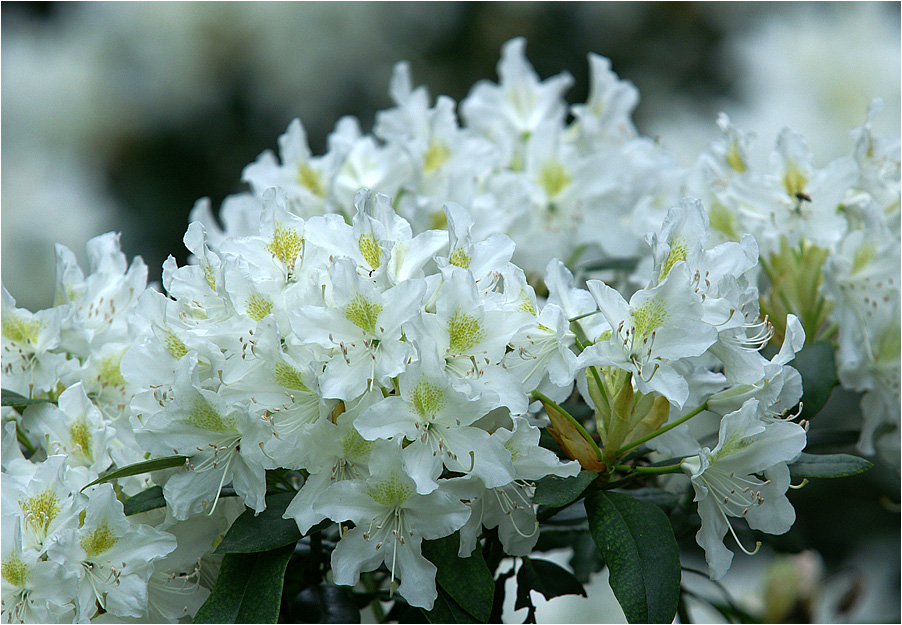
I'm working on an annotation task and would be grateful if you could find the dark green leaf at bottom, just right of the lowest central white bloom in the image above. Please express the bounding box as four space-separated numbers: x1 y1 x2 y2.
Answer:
423 532 495 623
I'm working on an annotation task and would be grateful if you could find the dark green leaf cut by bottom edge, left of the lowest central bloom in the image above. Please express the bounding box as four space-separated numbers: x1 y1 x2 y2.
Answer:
194 545 294 623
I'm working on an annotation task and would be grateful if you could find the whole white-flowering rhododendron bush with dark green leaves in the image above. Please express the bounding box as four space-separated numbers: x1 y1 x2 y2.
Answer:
2 39 900 622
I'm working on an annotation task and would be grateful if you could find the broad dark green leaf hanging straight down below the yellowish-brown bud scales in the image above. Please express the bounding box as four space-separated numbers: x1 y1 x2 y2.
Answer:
586 491 680 623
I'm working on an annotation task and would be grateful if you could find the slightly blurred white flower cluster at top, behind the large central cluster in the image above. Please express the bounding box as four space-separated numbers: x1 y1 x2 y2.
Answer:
193 39 676 276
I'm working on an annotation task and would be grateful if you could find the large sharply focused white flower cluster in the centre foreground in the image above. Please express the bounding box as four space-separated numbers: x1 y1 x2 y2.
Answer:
133 189 578 608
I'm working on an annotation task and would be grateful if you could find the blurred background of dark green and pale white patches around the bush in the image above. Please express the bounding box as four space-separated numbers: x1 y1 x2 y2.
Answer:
0 2 902 622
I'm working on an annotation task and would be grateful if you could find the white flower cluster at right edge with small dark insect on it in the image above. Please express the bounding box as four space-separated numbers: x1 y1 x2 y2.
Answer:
689 105 900 456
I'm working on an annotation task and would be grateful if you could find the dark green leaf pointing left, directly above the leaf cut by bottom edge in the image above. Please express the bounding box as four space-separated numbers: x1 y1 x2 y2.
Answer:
213 491 301 553
